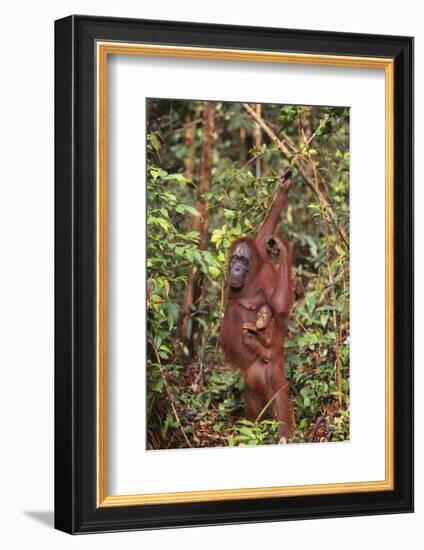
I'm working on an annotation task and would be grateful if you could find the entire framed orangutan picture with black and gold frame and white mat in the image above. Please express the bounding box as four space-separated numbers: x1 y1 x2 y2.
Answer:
55 16 413 534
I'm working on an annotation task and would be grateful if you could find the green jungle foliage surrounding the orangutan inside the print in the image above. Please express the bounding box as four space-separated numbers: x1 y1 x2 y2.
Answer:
147 99 349 449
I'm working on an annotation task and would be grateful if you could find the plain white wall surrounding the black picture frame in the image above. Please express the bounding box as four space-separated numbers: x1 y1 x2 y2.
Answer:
0 0 418 550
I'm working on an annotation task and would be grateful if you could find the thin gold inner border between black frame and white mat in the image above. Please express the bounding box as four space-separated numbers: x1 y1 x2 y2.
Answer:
96 41 394 508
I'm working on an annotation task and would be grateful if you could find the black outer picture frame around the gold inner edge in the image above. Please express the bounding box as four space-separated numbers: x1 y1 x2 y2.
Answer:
55 15 413 534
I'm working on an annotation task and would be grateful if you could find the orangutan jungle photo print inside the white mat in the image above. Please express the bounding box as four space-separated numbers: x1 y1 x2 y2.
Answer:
146 98 350 450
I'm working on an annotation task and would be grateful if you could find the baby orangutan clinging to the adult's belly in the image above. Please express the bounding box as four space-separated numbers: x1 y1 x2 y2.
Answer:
243 304 275 363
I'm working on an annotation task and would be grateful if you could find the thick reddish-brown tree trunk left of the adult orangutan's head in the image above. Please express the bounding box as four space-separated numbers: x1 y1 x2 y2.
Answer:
178 101 215 343
